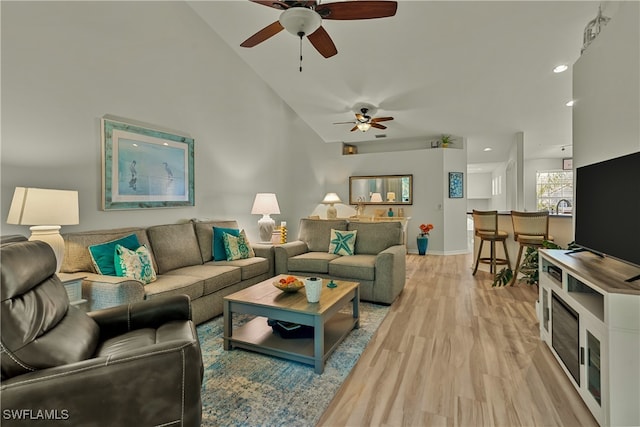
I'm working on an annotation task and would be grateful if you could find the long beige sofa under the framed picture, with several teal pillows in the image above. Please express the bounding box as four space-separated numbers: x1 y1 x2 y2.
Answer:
61 221 274 324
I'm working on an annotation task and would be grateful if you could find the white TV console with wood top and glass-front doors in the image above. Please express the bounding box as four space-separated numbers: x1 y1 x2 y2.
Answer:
538 249 640 426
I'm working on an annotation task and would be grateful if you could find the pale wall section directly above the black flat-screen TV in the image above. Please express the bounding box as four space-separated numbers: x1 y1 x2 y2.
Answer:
573 1 640 168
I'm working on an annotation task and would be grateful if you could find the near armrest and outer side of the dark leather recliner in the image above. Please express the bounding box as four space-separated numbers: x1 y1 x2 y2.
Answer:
1 322 203 427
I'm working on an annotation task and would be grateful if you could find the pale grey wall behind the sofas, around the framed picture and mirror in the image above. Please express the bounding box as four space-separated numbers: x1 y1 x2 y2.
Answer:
0 1 466 253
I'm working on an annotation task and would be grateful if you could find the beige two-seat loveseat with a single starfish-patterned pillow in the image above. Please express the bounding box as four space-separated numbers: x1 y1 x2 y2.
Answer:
275 218 406 304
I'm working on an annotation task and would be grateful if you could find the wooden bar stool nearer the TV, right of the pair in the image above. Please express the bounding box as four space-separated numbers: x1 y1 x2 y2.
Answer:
510 211 553 285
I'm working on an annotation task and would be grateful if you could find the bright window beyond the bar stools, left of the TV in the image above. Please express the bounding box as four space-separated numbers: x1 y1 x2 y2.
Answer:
536 171 573 213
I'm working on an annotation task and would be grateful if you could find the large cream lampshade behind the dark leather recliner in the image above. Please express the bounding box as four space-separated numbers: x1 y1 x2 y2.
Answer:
7 187 80 225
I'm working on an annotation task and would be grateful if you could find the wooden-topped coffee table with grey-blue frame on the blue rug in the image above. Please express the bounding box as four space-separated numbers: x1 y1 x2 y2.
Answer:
224 275 360 374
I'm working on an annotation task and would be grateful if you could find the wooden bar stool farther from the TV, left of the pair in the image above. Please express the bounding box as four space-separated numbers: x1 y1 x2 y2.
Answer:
473 209 511 275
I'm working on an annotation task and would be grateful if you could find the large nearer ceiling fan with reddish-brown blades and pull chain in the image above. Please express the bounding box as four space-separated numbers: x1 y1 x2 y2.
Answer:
240 0 398 58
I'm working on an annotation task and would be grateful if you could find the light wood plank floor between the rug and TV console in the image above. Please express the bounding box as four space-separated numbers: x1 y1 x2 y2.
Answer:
318 255 597 427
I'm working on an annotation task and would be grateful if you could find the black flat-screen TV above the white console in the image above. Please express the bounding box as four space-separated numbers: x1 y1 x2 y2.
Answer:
574 152 640 267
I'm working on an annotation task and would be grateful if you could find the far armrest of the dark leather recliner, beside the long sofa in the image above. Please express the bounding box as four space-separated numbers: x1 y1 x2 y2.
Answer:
88 295 191 340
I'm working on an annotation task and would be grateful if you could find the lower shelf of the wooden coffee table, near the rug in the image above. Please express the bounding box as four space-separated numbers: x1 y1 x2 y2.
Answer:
224 313 358 373
